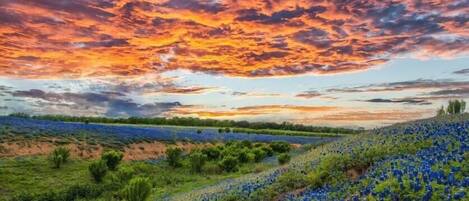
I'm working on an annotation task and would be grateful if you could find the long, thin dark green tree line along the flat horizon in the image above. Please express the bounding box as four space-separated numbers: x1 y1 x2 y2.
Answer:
10 113 362 134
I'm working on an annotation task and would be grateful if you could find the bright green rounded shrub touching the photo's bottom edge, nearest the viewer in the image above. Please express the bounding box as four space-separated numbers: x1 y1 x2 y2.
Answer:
122 177 152 201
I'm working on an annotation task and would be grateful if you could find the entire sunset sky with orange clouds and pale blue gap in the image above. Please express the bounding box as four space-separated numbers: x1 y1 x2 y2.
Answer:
0 0 469 128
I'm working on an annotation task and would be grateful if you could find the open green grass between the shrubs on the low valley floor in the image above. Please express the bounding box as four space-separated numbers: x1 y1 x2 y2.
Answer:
0 156 274 200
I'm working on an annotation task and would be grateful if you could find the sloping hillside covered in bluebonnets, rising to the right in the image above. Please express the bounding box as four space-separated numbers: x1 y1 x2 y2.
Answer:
173 114 469 201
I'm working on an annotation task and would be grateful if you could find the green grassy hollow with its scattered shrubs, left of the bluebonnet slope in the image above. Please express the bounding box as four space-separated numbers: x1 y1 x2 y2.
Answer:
0 141 300 201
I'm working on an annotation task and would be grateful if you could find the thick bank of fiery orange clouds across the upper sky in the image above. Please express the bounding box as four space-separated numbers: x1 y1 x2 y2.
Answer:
0 0 469 79
